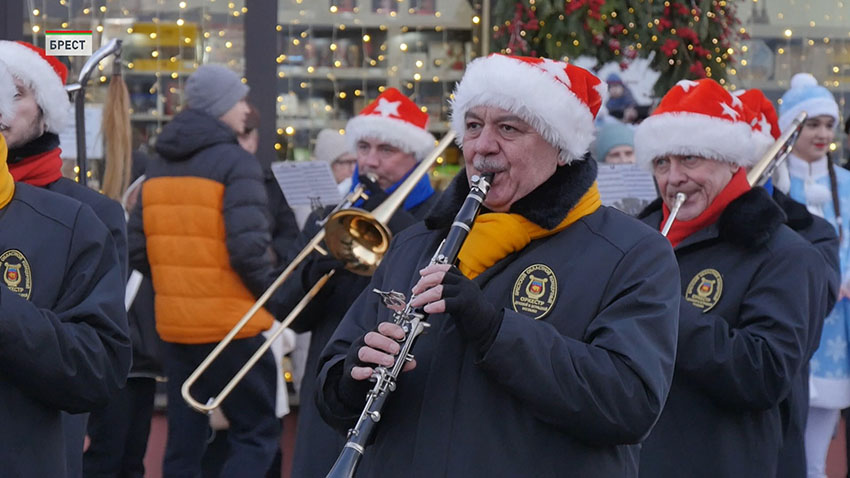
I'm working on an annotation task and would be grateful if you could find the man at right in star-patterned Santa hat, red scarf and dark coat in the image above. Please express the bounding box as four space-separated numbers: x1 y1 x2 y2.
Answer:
635 79 827 478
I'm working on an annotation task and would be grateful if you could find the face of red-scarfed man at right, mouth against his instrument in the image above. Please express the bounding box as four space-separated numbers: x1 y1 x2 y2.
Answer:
652 155 738 221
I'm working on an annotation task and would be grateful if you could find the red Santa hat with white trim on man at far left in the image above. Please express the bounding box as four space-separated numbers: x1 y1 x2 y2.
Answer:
0 40 71 133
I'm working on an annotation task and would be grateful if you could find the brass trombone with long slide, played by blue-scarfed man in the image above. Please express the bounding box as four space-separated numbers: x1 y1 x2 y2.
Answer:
180 130 455 413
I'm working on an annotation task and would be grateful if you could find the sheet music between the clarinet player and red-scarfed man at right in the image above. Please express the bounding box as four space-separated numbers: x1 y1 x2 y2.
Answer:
596 163 658 216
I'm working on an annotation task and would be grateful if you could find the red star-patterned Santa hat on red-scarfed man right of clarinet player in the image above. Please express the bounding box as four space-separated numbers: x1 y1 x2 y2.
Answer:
635 79 761 168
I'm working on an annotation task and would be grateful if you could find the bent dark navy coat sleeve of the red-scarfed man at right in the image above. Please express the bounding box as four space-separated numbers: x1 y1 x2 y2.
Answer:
676 243 824 410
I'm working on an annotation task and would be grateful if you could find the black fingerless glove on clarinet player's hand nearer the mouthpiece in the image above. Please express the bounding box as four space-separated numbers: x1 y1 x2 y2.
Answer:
443 266 504 352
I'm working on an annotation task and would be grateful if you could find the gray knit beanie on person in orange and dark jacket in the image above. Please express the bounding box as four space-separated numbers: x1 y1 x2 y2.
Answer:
185 64 249 118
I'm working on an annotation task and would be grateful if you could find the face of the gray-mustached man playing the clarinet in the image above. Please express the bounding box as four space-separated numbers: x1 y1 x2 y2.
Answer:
463 106 559 212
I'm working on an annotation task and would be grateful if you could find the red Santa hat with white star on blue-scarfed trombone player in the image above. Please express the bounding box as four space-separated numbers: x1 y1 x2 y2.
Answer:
345 88 436 161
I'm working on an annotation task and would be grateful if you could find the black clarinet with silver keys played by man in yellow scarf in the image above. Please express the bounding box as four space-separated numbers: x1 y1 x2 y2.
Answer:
327 174 493 478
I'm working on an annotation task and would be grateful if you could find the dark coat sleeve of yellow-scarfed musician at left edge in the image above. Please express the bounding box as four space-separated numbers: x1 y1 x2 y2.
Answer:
0 206 130 413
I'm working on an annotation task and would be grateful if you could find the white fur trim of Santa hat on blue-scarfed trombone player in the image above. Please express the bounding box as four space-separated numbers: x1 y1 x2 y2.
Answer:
345 115 436 161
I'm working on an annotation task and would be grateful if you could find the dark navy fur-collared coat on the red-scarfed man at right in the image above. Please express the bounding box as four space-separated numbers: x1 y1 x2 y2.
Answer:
640 188 827 478
